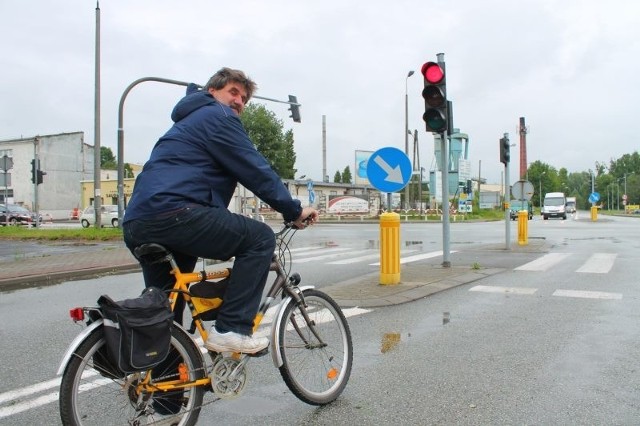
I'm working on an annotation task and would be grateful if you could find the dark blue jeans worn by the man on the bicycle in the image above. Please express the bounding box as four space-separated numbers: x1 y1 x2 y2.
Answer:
123 205 276 335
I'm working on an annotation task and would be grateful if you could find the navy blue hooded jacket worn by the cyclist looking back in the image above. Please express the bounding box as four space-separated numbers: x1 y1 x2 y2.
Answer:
124 85 302 223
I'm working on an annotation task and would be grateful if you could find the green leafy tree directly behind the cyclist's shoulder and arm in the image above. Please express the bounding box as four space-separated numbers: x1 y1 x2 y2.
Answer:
240 103 297 179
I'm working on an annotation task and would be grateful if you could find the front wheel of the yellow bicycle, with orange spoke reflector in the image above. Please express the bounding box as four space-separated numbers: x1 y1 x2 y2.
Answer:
276 289 353 405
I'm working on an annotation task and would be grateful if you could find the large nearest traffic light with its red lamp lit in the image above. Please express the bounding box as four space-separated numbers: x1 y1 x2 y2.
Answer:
421 62 449 133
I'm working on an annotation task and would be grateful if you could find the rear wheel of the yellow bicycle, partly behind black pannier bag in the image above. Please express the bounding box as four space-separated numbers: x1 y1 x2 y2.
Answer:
59 324 206 426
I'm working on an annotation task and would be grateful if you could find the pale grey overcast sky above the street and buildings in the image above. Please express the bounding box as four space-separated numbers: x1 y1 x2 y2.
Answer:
0 0 640 182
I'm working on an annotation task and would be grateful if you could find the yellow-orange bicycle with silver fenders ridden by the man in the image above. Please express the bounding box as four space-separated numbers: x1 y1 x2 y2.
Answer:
58 224 353 425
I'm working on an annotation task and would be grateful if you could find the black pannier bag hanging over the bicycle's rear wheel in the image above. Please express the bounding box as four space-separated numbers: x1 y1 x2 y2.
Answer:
98 287 173 373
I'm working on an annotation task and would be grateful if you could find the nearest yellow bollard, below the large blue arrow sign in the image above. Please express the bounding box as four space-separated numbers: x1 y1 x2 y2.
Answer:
380 213 400 285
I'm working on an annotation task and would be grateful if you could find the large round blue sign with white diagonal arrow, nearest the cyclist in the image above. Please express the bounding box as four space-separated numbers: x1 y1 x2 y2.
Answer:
367 147 411 192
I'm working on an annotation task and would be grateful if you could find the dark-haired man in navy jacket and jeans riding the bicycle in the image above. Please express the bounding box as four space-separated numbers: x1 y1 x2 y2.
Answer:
123 68 318 353
